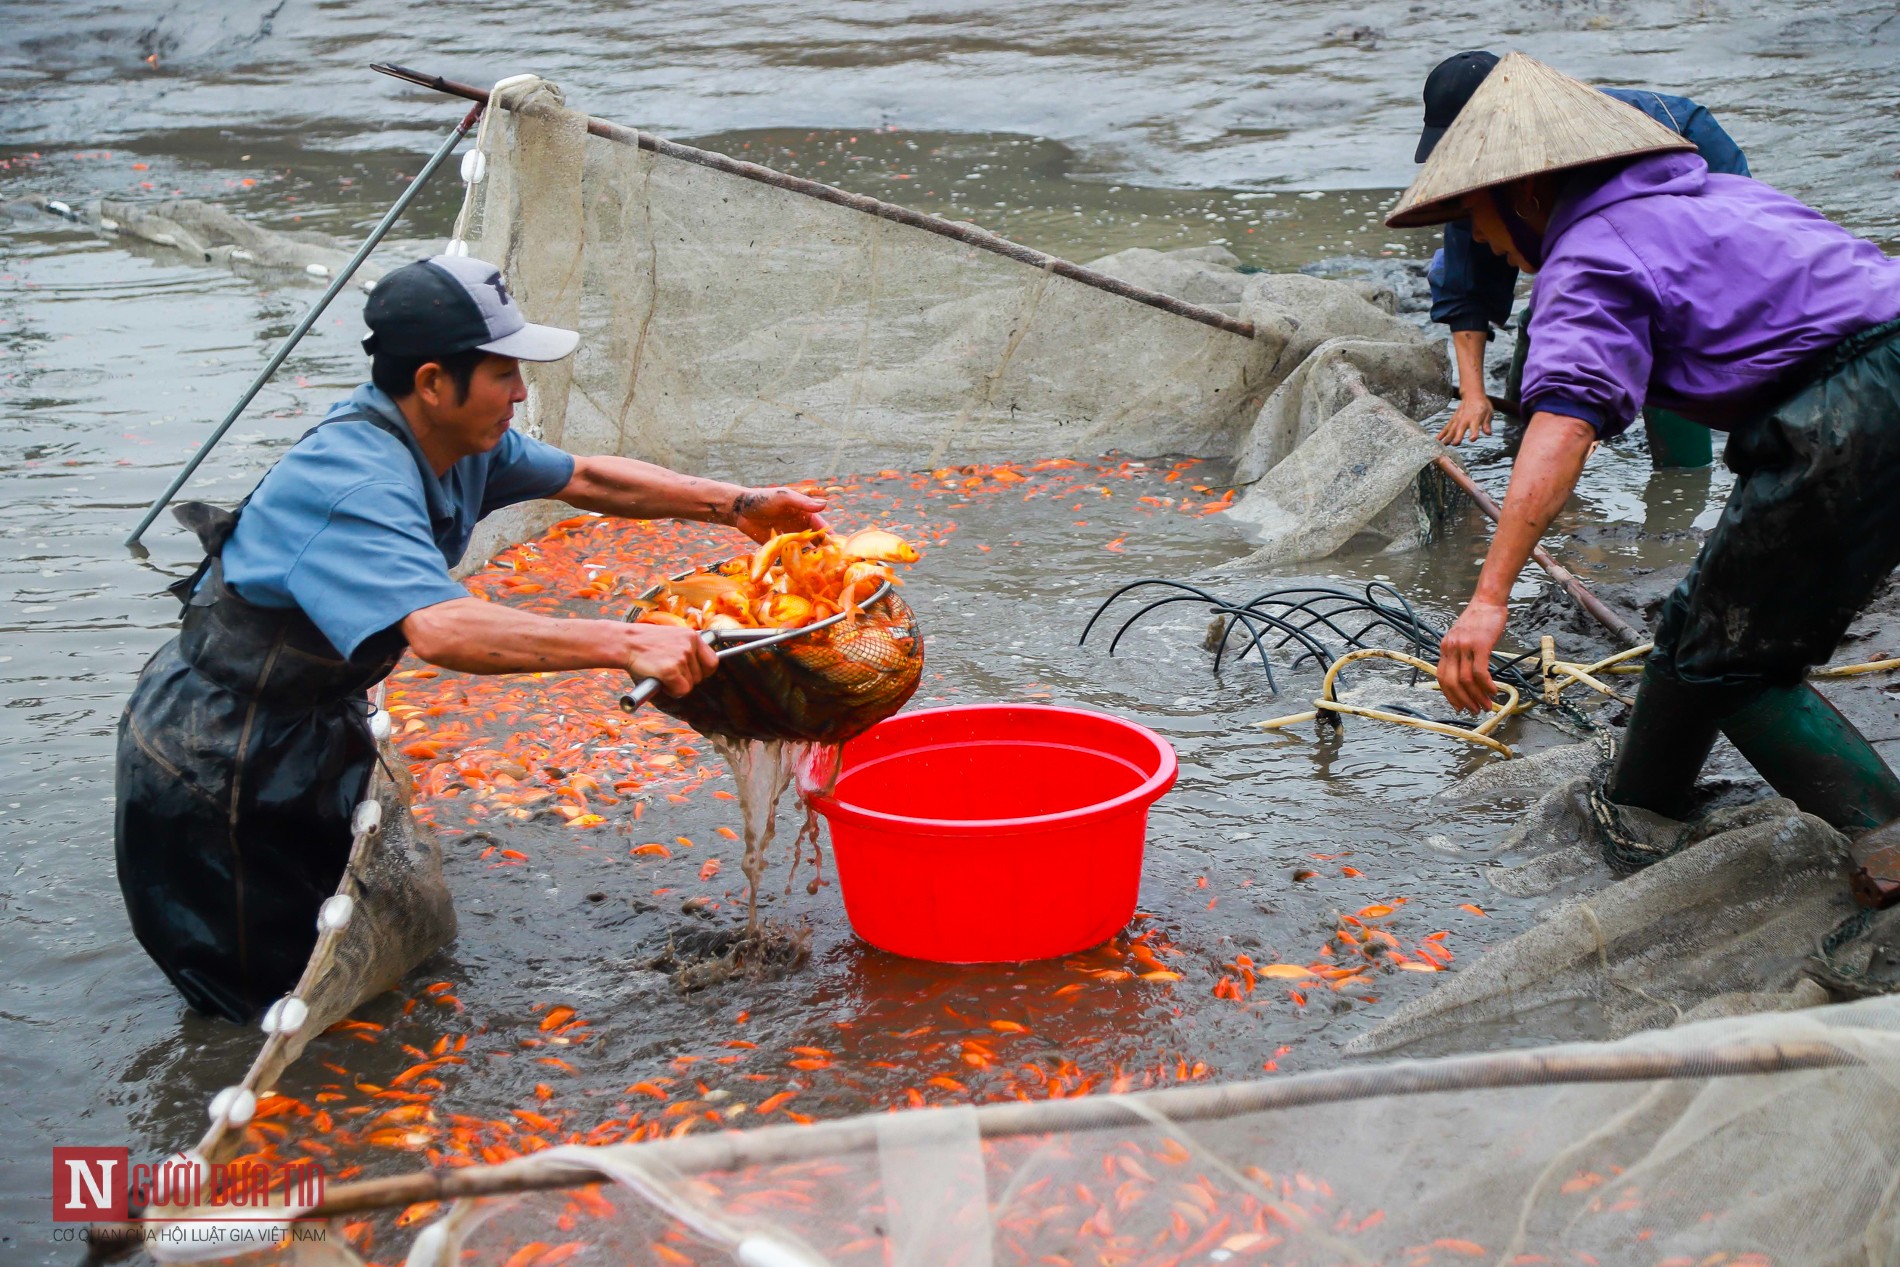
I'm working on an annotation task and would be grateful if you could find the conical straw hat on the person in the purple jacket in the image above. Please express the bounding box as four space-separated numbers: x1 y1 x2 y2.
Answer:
1385 53 1695 228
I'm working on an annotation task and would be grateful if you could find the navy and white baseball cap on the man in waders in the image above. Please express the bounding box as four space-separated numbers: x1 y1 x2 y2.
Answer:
363 255 581 361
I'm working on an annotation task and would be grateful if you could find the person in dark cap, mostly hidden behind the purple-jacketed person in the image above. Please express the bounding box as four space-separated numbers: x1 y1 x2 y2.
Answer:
1414 51 1748 467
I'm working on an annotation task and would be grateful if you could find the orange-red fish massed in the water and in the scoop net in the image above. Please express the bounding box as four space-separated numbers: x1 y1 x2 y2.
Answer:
200 460 1740 1267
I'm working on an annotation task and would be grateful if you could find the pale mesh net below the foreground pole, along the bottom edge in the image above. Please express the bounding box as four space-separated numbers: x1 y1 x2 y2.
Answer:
345 999 1900 1267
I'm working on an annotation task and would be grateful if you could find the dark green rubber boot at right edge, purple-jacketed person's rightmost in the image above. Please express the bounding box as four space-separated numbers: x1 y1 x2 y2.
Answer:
1717 678 1900 836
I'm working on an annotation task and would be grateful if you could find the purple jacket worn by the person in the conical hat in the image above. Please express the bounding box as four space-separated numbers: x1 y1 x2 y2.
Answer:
1524 152 1900 439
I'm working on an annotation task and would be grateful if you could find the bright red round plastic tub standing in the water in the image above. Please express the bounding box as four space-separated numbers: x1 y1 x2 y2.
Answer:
817 705 1176 963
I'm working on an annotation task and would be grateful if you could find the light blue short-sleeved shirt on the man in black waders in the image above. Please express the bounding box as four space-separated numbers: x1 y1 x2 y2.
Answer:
224 384 574 655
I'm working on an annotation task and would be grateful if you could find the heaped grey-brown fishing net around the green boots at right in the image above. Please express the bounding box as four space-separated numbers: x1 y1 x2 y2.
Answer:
1347 759 1900 1054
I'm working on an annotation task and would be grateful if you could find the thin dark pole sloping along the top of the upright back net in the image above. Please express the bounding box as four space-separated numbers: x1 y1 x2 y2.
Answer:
371 61 1254 338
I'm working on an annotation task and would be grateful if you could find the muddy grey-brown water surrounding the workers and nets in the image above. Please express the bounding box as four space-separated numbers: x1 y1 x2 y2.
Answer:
0 2 1900 1259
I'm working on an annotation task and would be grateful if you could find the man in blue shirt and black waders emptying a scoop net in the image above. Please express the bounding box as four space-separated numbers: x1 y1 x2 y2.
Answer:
116 256 825 1022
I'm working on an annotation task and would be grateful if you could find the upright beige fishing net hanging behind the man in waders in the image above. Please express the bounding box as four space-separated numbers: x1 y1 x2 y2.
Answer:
456 76 1446 558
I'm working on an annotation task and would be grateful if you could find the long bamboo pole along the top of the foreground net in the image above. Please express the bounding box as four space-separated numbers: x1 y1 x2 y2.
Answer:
87 1041 1864 1263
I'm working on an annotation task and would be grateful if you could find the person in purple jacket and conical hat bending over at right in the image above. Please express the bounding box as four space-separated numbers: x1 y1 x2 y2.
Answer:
1387 55 1900 897
